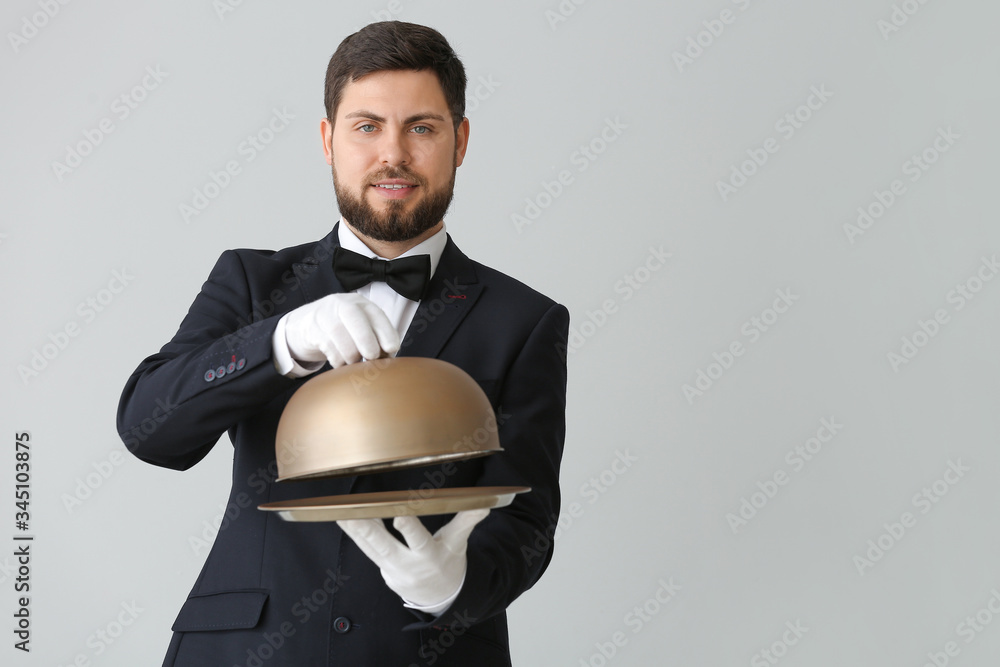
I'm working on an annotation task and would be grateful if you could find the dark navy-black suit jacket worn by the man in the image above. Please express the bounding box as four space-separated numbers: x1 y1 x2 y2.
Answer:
118 228 569 667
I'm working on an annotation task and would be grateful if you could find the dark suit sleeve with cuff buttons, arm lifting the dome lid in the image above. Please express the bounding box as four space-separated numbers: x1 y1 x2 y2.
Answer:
117 250 292 470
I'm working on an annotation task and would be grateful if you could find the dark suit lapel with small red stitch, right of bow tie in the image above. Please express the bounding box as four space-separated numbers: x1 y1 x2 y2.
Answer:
397 236 483 357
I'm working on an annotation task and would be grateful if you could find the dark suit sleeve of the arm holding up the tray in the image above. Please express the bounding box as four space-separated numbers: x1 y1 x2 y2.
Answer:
410 305 569 627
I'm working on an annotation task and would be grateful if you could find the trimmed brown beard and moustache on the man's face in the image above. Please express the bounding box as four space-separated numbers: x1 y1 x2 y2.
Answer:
333 160 457 243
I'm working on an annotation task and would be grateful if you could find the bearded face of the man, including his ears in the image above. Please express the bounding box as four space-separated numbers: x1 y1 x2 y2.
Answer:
320 70 469 242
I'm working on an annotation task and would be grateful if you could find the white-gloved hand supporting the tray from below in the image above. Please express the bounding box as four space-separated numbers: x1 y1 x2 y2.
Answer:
337 509 490 614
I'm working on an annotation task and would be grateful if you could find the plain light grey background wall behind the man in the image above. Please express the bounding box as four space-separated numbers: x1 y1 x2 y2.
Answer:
0 0 1000 666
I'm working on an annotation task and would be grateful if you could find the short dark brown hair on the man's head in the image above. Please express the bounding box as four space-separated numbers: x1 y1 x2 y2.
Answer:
323 21 466 131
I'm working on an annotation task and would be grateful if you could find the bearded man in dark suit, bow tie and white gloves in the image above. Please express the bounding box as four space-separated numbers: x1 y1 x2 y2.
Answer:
118 22 568 667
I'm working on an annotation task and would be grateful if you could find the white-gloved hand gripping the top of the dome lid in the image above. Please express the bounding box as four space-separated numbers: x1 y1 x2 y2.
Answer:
285 293 400 368
